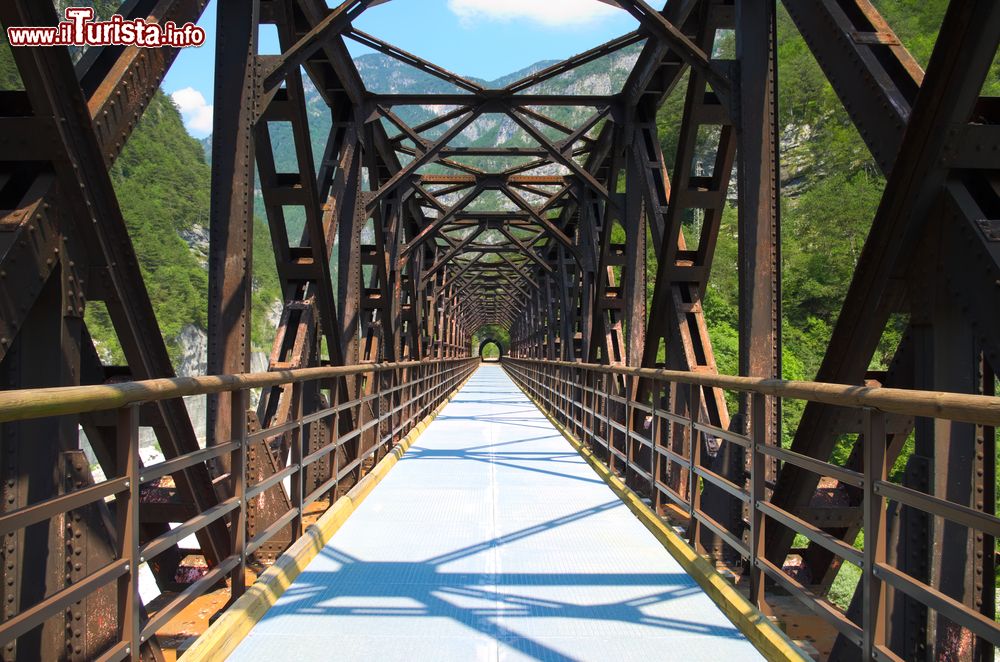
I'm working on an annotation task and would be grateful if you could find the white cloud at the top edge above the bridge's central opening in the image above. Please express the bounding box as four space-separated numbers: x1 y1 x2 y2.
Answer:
448 0 618 27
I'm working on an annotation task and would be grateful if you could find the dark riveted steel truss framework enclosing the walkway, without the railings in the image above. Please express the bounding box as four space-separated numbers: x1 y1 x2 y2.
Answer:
0 0 1000 655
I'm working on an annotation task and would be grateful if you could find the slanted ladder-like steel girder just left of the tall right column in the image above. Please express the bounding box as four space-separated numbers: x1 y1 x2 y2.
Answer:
628 3 742 560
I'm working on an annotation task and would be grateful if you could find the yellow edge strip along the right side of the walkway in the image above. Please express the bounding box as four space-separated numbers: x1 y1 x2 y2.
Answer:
511 379 812 662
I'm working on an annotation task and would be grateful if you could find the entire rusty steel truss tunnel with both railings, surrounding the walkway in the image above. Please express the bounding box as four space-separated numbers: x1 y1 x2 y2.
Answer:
0 0 1000 661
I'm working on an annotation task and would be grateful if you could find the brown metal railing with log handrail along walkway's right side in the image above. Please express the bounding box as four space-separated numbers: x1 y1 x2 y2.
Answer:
503 358 1000 660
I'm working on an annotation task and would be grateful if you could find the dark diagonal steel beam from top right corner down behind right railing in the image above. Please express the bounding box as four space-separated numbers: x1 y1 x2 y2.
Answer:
768 0 996 580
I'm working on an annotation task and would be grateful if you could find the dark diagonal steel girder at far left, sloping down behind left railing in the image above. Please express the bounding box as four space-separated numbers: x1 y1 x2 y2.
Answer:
2 3 229 580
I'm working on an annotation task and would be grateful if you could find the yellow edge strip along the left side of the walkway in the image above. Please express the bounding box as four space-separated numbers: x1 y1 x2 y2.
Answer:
181 371 475 662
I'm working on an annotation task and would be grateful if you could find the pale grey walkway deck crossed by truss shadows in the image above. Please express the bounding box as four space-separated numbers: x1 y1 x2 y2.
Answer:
229 365 762 662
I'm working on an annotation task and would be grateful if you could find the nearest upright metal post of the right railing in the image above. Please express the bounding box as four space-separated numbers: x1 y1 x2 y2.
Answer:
861 409 888 660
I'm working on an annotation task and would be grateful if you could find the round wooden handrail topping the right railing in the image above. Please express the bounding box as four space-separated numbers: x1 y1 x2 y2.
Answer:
504 357 1000 427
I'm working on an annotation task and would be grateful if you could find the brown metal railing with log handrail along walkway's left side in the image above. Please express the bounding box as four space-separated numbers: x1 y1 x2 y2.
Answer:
0 359 479 660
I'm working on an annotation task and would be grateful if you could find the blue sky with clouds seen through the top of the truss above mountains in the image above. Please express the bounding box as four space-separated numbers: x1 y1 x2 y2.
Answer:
163 0 636 138
